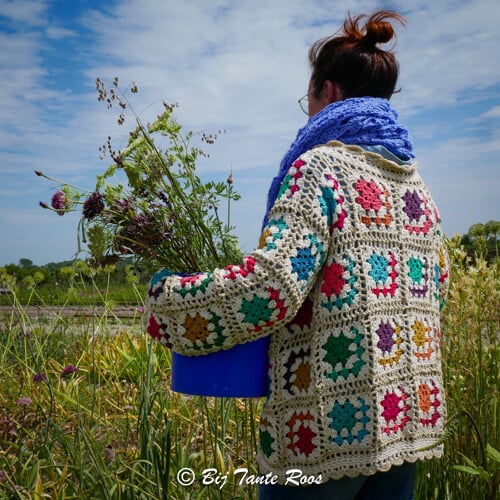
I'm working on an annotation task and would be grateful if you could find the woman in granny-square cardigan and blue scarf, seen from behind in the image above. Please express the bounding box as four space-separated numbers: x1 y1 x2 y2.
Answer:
148 11 447 500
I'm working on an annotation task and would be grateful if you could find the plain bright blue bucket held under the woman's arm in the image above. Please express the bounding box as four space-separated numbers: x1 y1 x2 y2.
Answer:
171 337 270 398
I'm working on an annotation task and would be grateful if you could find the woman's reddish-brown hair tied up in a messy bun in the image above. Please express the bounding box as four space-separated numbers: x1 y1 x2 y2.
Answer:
309 10 406 99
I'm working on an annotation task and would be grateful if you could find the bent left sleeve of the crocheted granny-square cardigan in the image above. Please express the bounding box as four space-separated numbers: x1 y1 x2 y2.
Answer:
146 152 338 355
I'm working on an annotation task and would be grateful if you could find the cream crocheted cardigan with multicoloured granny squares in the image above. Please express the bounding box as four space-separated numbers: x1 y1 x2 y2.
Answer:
147 141 448 482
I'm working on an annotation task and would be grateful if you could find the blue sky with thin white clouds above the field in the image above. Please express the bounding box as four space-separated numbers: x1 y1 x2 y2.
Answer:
0 0 500 266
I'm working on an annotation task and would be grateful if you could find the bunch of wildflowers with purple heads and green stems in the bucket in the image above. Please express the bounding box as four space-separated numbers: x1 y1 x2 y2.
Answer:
36 79 241 272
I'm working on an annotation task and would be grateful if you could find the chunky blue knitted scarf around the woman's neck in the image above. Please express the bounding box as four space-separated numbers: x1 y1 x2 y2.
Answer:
262 97 415 228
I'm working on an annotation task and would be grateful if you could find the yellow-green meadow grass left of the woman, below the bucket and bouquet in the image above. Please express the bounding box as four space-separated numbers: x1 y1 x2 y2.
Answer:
0 280 259 499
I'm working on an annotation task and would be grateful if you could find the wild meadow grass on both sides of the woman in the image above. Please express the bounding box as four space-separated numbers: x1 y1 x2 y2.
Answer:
0 236 500 500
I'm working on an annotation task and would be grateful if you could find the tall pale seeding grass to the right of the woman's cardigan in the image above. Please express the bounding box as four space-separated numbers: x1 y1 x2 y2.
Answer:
416 238 500 500
